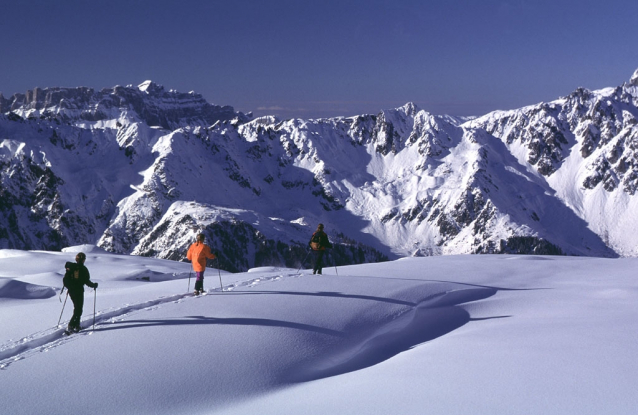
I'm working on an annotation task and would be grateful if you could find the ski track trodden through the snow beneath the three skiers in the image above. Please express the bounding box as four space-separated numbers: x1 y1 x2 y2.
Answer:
0 273 290 370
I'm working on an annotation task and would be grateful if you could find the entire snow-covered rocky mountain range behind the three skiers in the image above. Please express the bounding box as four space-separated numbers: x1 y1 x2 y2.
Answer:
0 74 638 271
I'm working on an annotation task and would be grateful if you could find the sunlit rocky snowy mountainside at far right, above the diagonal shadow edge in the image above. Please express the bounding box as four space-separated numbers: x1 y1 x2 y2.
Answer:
463 71 638 255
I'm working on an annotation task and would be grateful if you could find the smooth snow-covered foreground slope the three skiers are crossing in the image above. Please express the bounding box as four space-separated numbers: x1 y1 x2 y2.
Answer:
0 246 638 415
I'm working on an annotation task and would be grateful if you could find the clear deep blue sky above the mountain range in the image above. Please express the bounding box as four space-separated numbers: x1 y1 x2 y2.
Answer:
0 0 638 118
